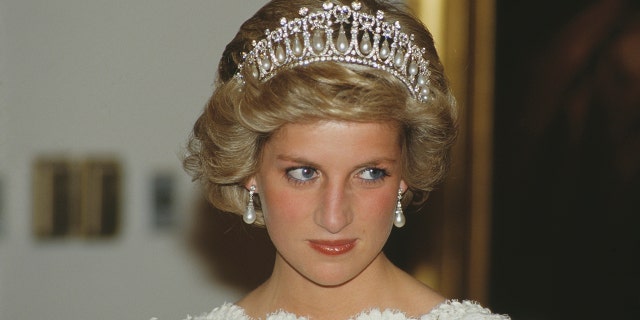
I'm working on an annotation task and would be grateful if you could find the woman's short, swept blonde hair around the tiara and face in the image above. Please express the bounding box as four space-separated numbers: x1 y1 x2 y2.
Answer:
184 0 457 224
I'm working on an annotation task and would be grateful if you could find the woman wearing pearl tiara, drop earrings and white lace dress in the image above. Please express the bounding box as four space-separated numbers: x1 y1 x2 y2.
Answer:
185 0 507 319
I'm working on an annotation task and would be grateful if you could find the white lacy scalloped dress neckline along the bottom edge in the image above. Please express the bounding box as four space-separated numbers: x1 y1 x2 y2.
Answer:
175 300 511 320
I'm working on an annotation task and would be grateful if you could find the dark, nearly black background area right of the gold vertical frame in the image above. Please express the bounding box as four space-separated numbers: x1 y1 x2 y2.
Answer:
490 0 640 320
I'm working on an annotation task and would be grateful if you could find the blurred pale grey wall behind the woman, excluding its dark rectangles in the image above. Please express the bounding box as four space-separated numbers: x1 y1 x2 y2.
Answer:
0 0 266 319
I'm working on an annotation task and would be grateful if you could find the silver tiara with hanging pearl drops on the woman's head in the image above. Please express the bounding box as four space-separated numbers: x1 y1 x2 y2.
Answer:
234 1 431 102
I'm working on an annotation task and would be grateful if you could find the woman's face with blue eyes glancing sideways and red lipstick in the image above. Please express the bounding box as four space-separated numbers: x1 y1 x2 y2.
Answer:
251 121 406 286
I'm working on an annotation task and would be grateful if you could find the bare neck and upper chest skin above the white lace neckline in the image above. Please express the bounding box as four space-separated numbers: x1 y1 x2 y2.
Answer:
238 253 442 320
